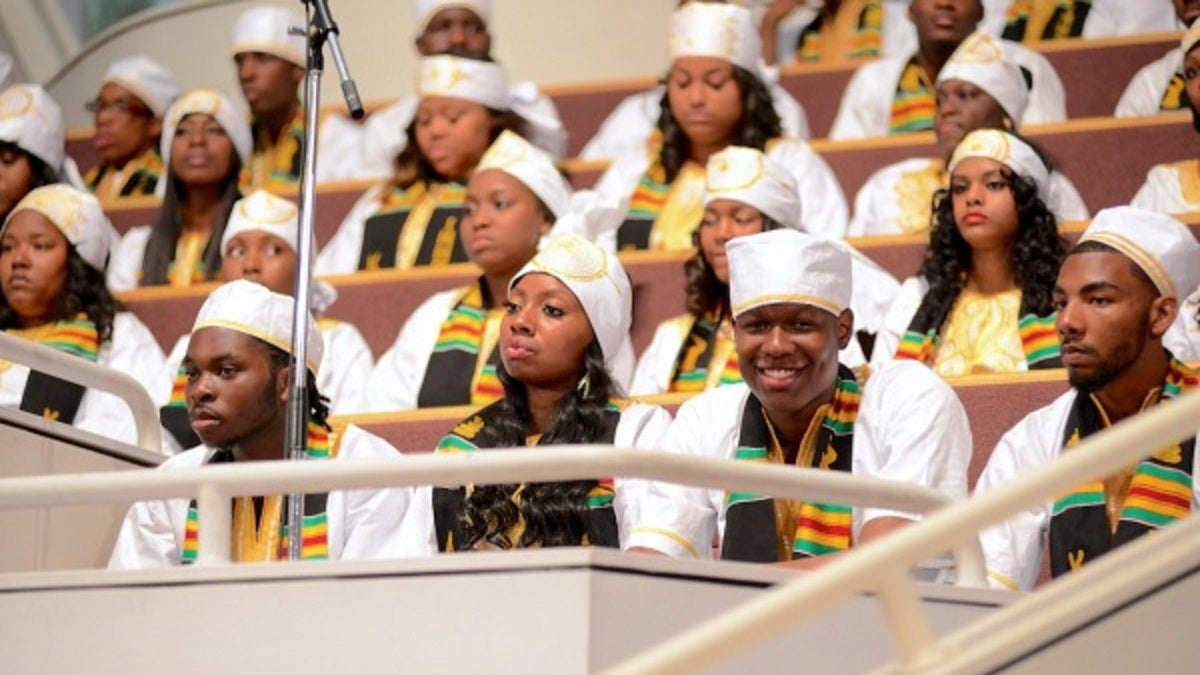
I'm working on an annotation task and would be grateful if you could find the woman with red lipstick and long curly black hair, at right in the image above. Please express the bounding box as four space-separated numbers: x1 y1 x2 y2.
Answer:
876 130 1067 376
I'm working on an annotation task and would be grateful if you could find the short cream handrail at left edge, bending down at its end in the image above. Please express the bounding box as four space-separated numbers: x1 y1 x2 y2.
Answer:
0 331 162 453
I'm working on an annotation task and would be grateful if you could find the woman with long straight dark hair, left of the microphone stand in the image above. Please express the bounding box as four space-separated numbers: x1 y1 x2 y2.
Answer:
108 88 253 291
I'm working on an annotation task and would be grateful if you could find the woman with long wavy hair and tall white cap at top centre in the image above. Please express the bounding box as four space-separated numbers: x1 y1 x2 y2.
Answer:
596 2 847 251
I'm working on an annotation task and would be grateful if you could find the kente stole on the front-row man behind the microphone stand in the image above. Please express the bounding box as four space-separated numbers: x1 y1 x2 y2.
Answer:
180 419 336 565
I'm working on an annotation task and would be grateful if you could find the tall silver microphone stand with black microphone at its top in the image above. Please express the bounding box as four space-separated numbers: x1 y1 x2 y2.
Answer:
284 0 362 561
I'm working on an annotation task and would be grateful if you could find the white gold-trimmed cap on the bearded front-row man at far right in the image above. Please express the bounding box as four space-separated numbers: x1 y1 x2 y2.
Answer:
1076 207 1200 301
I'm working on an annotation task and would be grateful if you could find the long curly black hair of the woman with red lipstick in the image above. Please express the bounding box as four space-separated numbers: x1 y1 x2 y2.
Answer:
912 166 1067 325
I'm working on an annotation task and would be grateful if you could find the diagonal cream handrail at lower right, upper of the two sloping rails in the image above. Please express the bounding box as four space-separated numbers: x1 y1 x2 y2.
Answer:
607 384 1200 675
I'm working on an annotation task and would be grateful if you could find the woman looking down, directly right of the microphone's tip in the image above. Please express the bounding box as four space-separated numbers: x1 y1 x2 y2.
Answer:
314 55 549 275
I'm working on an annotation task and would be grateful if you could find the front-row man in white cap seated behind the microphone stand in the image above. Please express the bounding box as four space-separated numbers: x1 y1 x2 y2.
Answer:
109 281 433 569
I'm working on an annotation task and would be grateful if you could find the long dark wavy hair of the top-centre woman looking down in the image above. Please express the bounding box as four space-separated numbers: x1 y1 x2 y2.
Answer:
659 66 784 183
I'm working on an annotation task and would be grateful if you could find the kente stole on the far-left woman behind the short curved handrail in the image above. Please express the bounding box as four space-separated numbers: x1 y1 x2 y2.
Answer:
8 315 100 424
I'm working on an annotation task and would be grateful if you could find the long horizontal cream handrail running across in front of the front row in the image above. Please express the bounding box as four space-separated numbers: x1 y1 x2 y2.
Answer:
0 446 984 585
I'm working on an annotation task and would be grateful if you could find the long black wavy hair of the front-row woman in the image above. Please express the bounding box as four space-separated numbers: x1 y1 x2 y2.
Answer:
456 339 619 549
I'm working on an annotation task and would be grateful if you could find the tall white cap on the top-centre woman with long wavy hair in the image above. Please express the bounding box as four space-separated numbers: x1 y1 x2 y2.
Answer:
668 2 762 77
